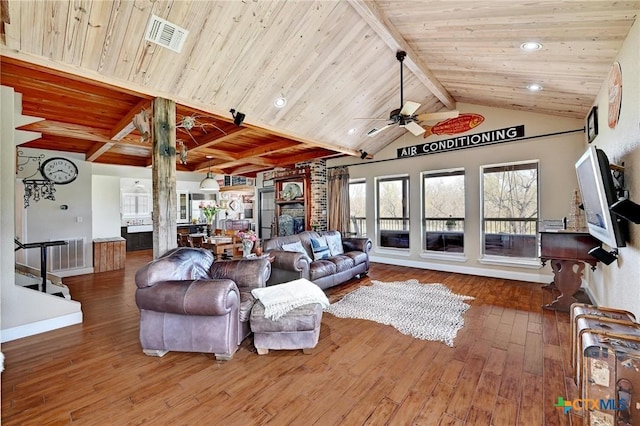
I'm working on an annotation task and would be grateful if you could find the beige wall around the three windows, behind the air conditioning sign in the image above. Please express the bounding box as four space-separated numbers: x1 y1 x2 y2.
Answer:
327 103 585 283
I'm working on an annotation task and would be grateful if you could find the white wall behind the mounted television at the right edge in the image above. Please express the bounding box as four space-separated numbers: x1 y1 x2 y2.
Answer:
583 20 640 318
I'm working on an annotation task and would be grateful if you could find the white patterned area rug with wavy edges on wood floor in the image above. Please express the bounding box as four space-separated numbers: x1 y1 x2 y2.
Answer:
326 279 474 346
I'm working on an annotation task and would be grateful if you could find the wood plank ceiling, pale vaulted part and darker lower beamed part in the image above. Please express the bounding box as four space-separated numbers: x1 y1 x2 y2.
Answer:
0 0 640 176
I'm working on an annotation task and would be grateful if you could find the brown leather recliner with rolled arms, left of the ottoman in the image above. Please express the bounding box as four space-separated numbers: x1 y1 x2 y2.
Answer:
135 247 271 360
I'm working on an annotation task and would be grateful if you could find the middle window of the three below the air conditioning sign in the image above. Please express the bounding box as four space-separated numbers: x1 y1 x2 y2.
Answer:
422 169 465 253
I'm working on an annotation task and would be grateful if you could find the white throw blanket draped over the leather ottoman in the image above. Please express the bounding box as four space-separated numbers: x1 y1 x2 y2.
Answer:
251 278 329 321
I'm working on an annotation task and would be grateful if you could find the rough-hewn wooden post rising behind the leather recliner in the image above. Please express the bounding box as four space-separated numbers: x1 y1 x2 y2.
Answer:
151 98 178 259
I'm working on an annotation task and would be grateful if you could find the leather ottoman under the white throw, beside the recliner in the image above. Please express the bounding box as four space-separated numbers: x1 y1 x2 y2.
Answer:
249 300 322 355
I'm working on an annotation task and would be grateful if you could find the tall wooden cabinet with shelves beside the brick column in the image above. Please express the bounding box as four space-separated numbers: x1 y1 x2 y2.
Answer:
273 167 311 236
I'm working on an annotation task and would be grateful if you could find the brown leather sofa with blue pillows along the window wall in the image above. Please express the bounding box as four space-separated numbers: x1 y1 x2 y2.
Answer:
263 231 372 289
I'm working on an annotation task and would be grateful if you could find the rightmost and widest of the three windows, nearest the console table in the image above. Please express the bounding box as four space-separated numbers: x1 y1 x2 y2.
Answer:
482 162 538 258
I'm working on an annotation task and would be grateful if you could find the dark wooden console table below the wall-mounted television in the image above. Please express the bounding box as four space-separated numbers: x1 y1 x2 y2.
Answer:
540 231 601 312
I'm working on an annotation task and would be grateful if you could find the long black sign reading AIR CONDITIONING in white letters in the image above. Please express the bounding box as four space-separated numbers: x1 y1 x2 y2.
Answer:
398 124 524 158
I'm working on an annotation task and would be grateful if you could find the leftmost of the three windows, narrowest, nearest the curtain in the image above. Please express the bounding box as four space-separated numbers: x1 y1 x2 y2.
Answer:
376 176 409 249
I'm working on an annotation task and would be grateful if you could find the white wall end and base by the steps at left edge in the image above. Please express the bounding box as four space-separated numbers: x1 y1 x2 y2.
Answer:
0 86 82 342
